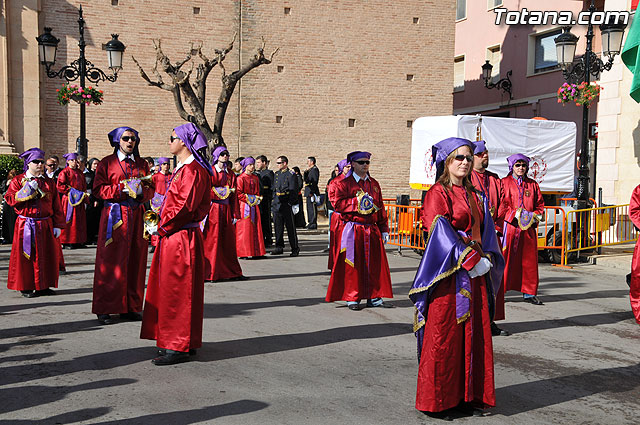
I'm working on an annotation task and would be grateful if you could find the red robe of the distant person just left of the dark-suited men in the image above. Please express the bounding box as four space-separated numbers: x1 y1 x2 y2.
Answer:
236 173 266 257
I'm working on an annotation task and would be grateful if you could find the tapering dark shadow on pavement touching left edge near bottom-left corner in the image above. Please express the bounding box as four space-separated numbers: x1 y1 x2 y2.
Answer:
0 378 138 413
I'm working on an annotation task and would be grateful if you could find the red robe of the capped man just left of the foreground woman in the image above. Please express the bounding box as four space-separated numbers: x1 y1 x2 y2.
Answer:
325 176 393 302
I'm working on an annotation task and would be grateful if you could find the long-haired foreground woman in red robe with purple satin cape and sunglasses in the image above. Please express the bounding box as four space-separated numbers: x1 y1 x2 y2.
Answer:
409 137 502 419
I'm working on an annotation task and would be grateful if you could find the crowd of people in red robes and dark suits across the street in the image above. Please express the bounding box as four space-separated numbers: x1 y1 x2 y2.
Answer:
5 129 640 420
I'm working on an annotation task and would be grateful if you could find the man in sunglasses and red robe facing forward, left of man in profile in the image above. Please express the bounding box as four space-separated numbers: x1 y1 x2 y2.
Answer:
92 127 154 325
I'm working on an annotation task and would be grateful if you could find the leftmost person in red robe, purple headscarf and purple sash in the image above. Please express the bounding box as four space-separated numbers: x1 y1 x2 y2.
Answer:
4 148 65 298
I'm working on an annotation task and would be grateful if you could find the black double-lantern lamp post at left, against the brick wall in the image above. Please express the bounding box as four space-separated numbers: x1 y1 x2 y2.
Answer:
36 6 126 157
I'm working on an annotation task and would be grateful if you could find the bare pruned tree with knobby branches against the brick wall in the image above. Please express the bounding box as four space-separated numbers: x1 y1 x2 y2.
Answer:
131 33 280 149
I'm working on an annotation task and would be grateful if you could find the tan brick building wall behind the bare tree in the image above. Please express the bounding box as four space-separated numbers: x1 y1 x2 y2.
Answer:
41 0 455 196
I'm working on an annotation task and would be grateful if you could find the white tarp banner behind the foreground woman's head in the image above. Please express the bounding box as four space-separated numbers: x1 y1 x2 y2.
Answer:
409 115 576 192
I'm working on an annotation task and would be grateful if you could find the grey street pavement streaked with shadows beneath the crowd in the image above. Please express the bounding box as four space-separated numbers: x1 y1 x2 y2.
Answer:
0 232 640 425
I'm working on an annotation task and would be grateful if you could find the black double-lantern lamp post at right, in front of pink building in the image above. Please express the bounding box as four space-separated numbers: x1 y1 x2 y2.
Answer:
554 0 626 209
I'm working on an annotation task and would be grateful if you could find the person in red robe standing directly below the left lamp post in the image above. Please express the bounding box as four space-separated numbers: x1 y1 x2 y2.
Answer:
57 152 89 249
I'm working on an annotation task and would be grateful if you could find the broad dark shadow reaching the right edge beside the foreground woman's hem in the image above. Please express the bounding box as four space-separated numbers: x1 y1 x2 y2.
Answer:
498 364 640 414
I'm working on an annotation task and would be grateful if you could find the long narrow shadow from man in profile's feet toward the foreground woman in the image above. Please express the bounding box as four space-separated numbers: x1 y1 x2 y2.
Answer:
196 323 412 362
